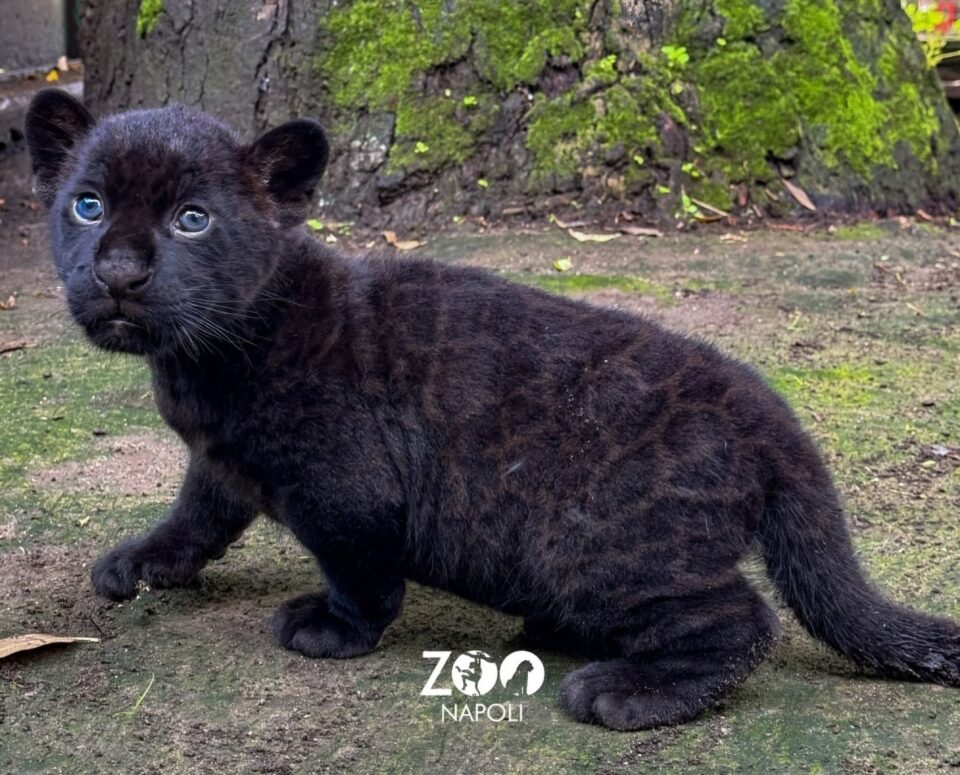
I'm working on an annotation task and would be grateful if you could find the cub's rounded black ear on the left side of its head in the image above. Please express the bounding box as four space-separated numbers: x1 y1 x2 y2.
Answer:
24 89 96 207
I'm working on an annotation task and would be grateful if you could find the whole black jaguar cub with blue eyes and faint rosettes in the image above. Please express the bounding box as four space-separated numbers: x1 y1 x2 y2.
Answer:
26 91 960 729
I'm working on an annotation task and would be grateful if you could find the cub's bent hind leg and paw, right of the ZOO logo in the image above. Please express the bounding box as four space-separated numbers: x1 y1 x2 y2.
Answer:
560 574 780 730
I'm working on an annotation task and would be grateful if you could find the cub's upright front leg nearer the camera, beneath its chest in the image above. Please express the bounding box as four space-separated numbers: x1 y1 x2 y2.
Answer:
273 500 405 658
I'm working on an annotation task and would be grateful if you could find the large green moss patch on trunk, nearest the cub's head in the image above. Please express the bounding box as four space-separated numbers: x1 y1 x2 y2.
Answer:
317 0 590 170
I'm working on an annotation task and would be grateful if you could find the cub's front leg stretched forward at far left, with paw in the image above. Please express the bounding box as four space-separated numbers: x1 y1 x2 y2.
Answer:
91 460 256 600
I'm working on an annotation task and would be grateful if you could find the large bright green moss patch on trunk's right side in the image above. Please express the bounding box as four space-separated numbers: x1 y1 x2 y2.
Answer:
691 0 940 188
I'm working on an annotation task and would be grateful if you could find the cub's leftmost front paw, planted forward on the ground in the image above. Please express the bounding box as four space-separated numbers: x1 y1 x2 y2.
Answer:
90 538 199 600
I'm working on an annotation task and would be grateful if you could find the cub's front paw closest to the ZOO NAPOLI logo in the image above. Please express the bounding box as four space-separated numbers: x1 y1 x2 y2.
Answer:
273 594 382 659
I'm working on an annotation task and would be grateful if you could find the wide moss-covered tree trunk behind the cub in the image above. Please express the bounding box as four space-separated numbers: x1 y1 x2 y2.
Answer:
81 0 960 230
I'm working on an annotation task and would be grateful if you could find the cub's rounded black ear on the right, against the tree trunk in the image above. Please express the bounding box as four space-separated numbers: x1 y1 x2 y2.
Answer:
248 118 329 226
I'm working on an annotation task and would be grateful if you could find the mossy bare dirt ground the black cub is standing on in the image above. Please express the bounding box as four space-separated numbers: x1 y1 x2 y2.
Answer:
0 149 960 773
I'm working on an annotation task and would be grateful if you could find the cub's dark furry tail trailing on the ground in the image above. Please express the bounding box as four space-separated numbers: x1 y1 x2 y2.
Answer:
760 437 960 686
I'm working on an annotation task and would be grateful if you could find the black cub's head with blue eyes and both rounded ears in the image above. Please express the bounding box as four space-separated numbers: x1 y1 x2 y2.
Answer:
26 89 327 354
